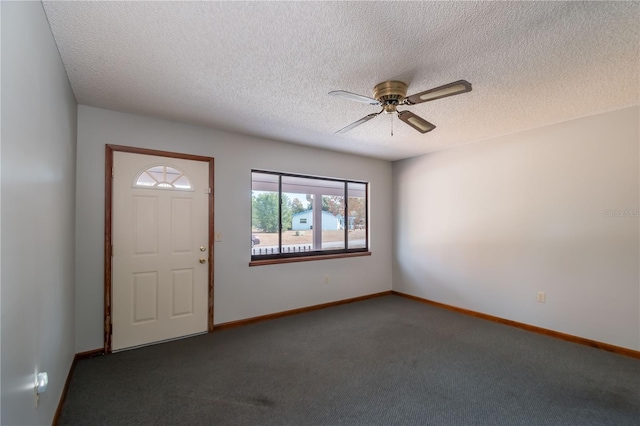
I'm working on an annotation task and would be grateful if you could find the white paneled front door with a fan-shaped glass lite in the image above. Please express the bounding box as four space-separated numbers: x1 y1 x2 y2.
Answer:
112 151 211 350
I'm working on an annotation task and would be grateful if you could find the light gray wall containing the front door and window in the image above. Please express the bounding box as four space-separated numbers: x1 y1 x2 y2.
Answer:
76 105 392 352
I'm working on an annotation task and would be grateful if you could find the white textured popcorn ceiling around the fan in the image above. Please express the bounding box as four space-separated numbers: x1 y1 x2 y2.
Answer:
44 1 640 160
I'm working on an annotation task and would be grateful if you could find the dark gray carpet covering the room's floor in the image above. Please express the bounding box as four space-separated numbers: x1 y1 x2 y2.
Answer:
60 296 640 426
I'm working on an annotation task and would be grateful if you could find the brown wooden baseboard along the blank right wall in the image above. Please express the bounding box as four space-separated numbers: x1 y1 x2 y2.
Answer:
391 290 640 359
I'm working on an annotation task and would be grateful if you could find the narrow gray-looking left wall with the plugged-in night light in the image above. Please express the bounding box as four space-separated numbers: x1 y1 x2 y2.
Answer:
0 1 77 425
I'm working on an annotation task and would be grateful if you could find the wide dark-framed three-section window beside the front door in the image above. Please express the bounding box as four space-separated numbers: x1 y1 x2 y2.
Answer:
251 170 369 261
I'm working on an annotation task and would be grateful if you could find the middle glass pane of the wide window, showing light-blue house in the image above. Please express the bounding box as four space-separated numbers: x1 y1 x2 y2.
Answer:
282 176 315 253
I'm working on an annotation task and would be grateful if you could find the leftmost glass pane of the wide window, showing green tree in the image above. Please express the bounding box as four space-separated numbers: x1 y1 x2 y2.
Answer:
251 172 280 256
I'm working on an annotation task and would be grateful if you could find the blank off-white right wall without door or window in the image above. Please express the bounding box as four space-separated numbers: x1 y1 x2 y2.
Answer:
393 107 640 350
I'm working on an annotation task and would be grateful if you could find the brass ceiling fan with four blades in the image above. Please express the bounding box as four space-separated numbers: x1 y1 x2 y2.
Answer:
329 80 471 135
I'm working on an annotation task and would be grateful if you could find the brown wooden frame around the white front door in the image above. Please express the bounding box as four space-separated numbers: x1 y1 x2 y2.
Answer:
104 144 215 353
